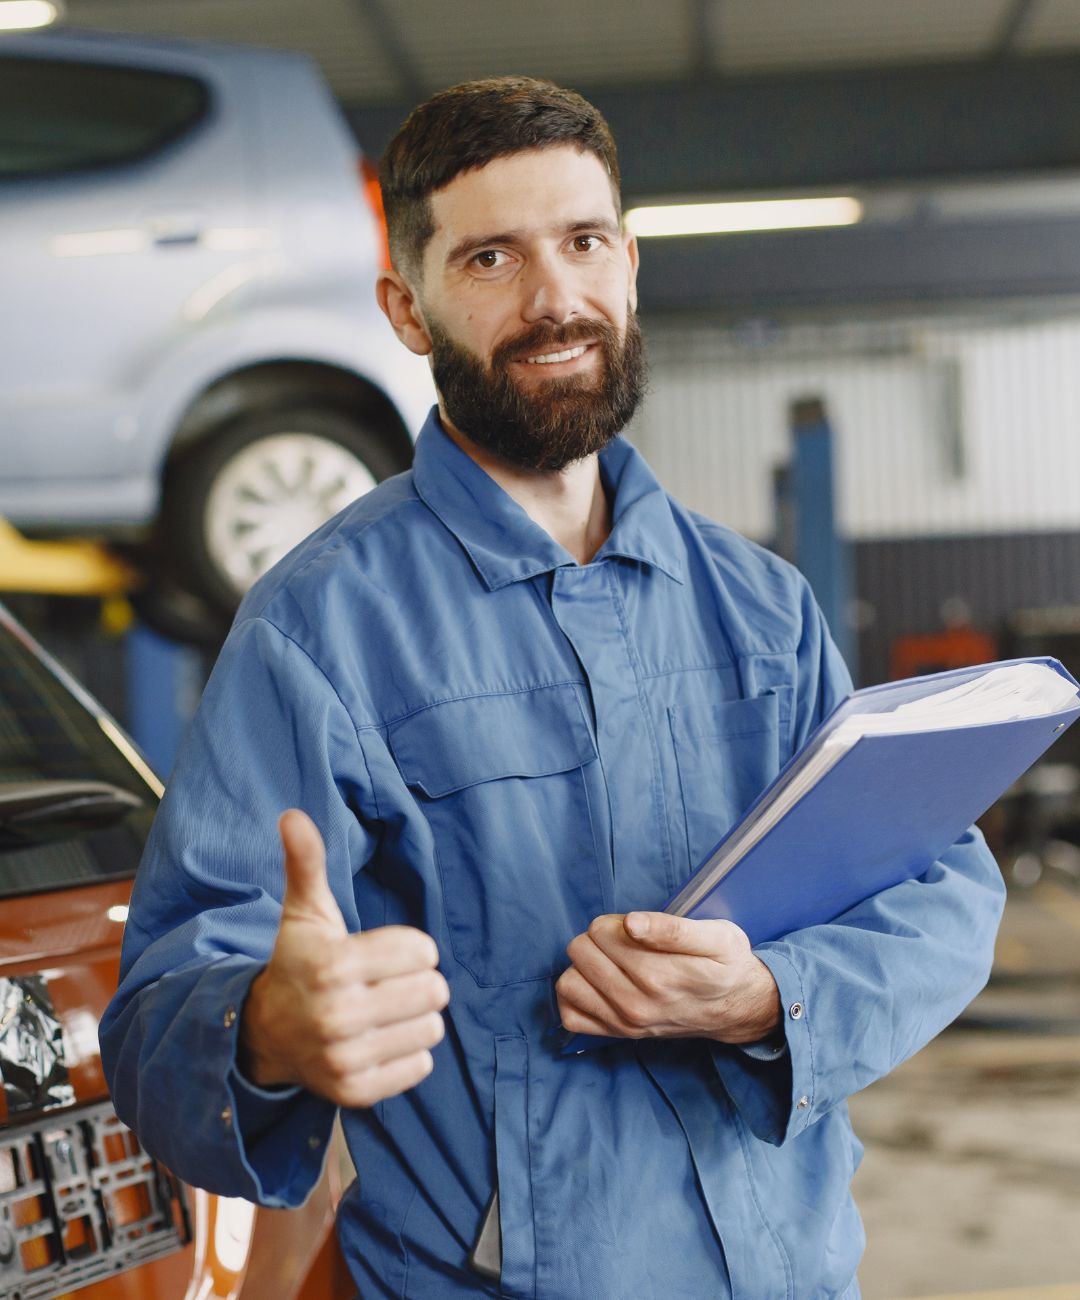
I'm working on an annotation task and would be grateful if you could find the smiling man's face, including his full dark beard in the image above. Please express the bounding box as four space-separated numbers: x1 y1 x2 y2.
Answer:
410 146 643 471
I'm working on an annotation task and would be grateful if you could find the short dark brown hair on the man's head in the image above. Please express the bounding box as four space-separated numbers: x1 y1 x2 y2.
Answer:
379 77 619 272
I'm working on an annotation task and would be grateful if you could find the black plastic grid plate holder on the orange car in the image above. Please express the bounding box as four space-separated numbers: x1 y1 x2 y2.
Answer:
0 1102 191 1300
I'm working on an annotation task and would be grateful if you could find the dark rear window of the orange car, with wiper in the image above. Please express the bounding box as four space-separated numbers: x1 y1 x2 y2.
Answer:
0 618 157 898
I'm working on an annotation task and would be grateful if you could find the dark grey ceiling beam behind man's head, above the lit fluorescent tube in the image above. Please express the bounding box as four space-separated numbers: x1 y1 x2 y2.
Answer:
350 55 1080 202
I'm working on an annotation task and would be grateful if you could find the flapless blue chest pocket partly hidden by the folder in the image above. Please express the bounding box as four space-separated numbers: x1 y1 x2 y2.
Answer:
668 686 793 875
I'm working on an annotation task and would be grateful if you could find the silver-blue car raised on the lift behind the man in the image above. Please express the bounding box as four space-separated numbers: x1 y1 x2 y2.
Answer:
0 30 433 624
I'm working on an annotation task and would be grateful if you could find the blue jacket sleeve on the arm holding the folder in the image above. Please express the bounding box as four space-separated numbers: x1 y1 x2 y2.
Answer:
712 580 1005 1144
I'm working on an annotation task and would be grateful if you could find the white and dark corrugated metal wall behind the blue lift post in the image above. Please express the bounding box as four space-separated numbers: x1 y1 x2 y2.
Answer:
633 302 1080 681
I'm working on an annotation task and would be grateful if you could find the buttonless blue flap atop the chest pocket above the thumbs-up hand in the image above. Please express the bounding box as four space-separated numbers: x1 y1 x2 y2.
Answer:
390 685 597 798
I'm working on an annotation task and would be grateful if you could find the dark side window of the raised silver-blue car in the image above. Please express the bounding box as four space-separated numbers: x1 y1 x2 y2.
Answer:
0 56 209 179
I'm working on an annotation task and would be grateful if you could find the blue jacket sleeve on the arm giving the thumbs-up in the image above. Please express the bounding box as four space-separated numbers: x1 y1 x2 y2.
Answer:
100 619 376 1206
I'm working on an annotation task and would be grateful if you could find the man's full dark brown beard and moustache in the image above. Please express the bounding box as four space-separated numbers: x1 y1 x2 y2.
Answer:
429 311 646 473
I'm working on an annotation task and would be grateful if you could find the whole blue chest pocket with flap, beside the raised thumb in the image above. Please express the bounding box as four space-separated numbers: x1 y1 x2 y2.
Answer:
390 685 603 985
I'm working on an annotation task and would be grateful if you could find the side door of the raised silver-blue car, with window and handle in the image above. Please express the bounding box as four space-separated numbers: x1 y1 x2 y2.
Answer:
0 38 251 524
